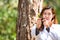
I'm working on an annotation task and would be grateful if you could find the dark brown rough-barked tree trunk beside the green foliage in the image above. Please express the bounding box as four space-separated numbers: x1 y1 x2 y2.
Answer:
16 0 30 40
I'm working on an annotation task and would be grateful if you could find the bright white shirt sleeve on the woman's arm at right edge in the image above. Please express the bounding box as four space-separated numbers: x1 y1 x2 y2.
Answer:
50 24 60 40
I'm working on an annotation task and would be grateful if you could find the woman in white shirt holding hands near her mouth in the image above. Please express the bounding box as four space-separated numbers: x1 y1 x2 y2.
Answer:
31 7 60 40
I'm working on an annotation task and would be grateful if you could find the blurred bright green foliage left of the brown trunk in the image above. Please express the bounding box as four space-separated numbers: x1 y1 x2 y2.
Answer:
0 0 17 40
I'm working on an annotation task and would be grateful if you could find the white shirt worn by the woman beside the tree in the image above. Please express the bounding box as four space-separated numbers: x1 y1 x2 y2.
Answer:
31 24 60 40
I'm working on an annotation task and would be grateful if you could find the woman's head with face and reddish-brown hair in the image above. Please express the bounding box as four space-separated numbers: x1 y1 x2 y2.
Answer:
40 7 58 24
